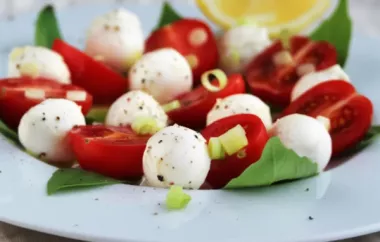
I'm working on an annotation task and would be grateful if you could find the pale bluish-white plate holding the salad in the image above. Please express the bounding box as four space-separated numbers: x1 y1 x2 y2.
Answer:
0 1 380 242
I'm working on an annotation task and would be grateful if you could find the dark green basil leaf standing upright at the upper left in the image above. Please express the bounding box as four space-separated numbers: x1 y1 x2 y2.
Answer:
34 5 62 48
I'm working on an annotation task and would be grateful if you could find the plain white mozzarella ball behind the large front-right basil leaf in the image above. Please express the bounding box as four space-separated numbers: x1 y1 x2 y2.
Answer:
270 114 332 171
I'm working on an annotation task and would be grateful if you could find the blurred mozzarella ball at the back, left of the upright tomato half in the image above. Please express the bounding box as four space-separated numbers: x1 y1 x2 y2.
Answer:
85 8 144 72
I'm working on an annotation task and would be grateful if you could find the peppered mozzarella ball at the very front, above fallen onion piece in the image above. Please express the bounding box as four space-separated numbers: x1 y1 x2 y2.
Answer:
143 125 211 189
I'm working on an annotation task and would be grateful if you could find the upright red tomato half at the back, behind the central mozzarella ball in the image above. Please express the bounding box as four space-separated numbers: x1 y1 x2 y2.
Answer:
146 19 219 82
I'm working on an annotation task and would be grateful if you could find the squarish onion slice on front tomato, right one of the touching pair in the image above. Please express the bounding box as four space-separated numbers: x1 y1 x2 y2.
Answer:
219 124 248 155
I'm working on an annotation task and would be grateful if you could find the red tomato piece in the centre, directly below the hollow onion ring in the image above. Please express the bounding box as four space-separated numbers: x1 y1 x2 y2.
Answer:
168 74 245 129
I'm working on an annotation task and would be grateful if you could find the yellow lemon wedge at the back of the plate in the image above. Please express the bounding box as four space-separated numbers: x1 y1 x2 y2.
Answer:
196 0 331 37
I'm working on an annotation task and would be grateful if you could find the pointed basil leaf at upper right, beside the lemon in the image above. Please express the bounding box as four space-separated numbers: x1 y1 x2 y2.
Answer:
310 0 352 67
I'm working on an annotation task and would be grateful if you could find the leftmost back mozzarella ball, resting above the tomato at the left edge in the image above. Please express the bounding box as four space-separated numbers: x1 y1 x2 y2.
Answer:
8 46 71 84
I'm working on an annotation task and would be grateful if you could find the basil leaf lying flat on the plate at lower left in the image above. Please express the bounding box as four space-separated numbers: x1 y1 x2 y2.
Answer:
47 168 122 195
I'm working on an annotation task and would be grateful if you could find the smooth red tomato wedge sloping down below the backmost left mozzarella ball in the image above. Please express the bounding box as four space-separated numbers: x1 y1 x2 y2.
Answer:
53 39 128 104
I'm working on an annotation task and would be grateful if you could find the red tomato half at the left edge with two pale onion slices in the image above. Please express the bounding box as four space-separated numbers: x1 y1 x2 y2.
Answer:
0 77 92 130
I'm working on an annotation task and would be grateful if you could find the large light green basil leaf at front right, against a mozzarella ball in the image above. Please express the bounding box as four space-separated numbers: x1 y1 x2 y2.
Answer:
224 137 318 189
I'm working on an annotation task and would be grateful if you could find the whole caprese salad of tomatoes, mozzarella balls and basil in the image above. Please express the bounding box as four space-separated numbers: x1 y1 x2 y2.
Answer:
0 0 376 208
